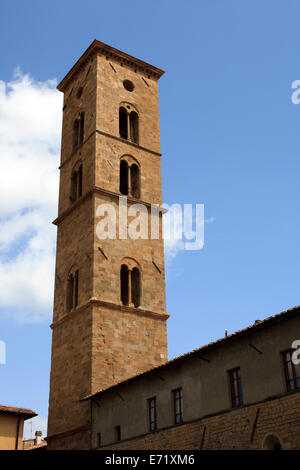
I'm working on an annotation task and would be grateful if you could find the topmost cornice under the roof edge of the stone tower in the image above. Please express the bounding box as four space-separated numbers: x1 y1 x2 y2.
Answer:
57 39 164 92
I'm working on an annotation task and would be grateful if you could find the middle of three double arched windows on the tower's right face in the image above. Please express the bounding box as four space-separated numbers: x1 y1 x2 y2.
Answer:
120 156 140 199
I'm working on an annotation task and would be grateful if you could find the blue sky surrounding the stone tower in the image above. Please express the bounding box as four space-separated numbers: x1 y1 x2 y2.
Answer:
0 0 300 438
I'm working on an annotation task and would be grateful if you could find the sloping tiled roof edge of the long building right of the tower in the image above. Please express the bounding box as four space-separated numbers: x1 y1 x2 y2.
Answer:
81 305 300 401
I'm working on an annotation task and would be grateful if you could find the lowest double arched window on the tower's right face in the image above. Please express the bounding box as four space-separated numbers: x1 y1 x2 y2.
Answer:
120 264 141 308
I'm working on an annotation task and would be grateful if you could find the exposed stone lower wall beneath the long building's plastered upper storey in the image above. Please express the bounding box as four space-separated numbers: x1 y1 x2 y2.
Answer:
102 392 300 450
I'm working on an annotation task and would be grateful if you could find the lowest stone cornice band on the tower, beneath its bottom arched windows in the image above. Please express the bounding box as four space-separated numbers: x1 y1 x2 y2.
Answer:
50 299 170 330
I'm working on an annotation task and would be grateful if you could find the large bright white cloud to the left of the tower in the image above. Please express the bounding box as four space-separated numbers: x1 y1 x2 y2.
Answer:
0 70 62 321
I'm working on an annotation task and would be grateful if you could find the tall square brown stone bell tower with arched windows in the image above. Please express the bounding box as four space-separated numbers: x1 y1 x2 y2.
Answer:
47 40 168 449
